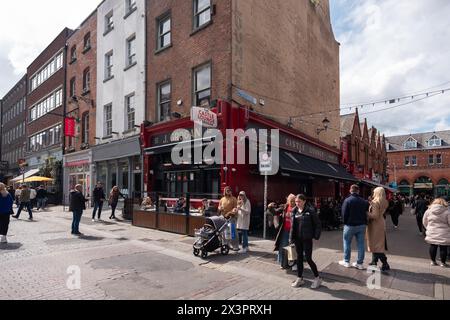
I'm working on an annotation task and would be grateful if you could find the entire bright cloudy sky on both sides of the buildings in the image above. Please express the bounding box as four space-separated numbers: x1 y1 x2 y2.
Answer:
0 0 450 136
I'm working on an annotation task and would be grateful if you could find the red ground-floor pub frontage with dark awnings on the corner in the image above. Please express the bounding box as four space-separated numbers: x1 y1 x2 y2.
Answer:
139 100 359 236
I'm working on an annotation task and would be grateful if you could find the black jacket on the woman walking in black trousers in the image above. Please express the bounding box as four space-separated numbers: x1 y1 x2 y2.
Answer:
289 206 322 243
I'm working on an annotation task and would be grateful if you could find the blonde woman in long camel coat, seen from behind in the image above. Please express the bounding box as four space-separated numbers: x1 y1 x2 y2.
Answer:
367 187 390 271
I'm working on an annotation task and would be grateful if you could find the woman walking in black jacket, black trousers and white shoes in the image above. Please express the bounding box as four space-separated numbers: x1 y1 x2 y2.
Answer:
289 194 322 289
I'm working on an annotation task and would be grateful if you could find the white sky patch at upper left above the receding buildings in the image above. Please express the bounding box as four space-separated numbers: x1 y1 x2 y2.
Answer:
0 0 100 96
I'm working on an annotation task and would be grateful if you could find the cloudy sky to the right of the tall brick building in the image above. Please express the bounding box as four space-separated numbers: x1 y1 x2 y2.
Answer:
334 0 450 135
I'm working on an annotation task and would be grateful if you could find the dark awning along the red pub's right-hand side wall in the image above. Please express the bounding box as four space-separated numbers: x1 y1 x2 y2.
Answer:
280 150 358 182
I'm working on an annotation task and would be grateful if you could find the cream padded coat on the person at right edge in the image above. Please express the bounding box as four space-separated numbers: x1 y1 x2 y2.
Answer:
423 204 450 246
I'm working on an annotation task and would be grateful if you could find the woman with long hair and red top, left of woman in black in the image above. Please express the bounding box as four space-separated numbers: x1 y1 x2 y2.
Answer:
274 194 295 269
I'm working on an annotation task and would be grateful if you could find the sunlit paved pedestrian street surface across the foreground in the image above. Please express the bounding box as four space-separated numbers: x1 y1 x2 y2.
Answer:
0 207 450 300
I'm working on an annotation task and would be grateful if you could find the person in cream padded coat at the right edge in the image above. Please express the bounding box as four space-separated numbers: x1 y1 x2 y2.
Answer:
423 198 450 268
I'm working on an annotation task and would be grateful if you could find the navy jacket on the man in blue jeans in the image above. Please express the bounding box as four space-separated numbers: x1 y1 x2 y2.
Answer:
342 193 369 227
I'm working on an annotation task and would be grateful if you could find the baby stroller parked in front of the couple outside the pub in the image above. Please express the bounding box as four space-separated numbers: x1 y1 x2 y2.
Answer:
194 216 231 259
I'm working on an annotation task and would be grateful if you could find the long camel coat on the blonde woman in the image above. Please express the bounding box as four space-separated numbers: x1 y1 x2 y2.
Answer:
366 202 388 253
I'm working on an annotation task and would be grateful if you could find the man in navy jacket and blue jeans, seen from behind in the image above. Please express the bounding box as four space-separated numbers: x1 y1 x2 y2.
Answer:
339 185 369 270
